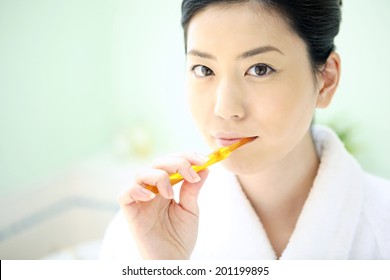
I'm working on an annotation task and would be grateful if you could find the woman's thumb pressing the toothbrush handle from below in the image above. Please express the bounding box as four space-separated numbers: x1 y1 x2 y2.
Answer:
179 169 209 215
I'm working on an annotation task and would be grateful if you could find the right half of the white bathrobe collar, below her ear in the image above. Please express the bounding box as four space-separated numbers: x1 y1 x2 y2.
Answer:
281 127 365 259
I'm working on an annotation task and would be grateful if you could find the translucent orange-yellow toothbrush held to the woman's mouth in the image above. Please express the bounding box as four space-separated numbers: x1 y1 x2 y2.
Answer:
145 137 257 194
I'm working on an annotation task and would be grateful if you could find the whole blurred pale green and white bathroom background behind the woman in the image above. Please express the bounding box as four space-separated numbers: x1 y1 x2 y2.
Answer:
0 0 390 259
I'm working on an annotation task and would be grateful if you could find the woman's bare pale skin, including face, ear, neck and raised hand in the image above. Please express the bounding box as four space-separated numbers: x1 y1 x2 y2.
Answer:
120 3 340 259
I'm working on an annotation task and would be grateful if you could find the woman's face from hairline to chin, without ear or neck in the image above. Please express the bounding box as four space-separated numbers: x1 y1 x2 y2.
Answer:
187 3 319 174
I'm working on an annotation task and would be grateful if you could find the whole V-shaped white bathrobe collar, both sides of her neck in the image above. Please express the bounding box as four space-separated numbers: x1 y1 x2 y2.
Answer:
193 126 364 259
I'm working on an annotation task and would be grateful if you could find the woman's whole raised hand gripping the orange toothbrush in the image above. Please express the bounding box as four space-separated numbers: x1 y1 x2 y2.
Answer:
119 155 208 259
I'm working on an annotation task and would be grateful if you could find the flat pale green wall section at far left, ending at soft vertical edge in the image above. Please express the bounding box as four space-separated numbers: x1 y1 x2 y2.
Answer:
0 0 114 194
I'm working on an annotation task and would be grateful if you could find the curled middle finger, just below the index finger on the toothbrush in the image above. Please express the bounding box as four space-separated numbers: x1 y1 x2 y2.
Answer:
136 169 173 199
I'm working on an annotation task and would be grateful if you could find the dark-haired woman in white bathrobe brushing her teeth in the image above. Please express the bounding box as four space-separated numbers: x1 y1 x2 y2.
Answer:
102 0 390 259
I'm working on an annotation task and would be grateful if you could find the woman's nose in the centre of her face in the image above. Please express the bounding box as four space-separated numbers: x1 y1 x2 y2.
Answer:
214 77 245 120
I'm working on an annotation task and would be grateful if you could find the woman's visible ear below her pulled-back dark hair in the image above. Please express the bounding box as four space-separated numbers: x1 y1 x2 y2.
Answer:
317 52 341 108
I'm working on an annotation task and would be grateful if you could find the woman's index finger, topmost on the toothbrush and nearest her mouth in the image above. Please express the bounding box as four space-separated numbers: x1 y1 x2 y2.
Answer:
153 154 204 183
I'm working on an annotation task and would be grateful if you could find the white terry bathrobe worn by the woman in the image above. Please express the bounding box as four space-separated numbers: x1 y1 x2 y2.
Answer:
101 126 390 260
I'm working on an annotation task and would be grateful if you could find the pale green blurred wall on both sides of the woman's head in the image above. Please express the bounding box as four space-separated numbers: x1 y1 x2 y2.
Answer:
0 0 390 195
